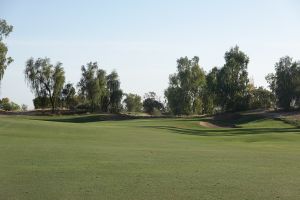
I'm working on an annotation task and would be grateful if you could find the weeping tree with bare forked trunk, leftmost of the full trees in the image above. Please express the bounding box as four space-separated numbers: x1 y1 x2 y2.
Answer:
25 58 65 112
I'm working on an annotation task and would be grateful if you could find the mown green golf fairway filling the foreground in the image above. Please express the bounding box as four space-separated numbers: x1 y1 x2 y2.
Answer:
0 115 300 200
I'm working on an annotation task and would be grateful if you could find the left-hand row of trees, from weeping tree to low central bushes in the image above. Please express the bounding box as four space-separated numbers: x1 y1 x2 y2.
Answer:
25 58 164 114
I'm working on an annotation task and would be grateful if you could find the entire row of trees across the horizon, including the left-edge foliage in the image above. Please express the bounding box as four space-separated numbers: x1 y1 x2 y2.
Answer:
0 19 300 115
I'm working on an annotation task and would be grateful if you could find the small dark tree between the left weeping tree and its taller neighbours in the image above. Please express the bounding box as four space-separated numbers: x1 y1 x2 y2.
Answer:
61 83 77 109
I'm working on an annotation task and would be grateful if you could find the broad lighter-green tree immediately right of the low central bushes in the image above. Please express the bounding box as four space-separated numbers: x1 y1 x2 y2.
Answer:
165 56 206 115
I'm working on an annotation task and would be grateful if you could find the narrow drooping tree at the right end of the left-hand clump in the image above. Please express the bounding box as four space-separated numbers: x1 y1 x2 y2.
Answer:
106 71 123 113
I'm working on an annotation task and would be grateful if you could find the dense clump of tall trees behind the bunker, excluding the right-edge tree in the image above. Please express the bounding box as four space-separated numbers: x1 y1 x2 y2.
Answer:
165 46 275 115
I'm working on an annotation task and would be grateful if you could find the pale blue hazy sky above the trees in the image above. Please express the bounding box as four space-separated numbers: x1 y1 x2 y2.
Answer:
0 0 300 108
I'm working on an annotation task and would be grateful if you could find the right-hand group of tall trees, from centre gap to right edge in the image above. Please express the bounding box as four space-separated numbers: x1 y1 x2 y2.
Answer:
165 46 300 115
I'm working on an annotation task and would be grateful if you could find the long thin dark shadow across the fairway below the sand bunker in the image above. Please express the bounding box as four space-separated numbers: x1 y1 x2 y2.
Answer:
143 126 300 136
